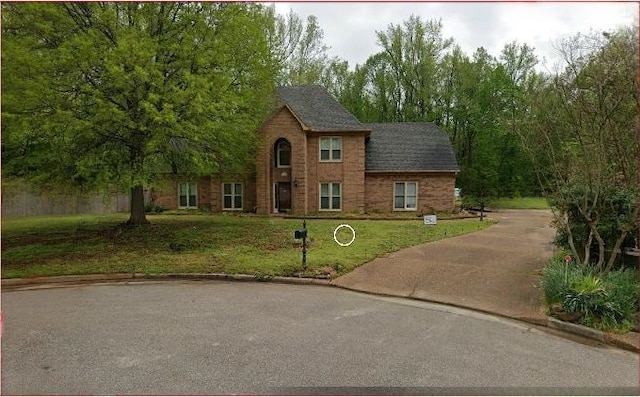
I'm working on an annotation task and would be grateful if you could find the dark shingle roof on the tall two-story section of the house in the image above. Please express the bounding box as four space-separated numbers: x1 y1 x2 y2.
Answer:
277 85 368 131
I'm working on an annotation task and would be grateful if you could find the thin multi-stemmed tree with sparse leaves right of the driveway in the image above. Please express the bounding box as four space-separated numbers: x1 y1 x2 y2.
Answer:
522 27 639 272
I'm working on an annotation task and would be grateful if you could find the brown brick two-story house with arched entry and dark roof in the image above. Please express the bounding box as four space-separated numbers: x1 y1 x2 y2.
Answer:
156 86 459 215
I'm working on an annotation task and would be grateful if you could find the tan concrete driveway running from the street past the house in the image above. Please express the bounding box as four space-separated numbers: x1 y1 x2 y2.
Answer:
334 210 554 323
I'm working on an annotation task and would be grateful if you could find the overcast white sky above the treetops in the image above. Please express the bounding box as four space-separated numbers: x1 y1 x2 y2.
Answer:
275 2 638 69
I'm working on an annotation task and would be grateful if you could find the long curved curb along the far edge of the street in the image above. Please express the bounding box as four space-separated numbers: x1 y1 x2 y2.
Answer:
2 273 640 353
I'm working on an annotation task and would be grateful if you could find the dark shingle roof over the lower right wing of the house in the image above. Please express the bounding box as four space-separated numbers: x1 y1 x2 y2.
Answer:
365 123 459 171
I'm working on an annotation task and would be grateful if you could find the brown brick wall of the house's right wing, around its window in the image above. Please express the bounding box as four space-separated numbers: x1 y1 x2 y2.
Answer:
365 173 456 214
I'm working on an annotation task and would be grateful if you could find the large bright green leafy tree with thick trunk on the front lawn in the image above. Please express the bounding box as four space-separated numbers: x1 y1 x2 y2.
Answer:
2 2 276 224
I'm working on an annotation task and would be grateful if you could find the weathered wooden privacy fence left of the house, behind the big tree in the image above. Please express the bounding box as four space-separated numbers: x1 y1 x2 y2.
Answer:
2 184 130 218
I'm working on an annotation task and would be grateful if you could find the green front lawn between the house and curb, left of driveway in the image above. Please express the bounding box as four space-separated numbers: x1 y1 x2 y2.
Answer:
2 214 491 278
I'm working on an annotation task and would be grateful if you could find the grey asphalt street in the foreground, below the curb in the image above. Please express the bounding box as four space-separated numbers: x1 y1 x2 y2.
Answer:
1 281 640 395
